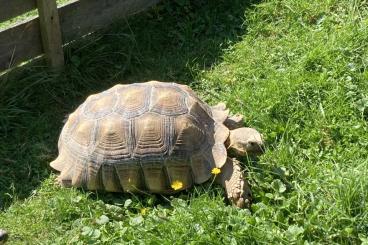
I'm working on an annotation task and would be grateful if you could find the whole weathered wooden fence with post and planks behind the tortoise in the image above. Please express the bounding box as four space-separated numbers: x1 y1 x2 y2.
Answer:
0 0 160 71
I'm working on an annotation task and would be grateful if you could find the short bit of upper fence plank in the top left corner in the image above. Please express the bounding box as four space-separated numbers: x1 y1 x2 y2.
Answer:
0 0 36 22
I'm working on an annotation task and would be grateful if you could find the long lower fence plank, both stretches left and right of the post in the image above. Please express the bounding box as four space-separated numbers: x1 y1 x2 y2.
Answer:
0 0 159 71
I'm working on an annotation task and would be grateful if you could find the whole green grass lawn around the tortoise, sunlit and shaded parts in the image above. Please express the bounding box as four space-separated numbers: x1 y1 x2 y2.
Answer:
0 0 368 244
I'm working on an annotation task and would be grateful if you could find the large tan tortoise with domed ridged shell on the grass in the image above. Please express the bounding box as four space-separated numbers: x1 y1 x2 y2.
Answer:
50 81 263 207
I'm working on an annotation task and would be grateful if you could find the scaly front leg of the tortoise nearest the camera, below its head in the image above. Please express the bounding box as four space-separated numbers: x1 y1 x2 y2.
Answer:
216 157 252 208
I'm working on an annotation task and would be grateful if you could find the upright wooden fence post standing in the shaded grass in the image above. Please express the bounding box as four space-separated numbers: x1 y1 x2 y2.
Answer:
37 0 64 69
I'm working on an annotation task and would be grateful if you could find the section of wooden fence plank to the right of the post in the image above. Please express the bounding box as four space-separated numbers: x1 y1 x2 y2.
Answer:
59 0 159 43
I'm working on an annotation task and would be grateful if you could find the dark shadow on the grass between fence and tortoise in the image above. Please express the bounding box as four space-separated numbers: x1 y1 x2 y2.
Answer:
0 0 255 208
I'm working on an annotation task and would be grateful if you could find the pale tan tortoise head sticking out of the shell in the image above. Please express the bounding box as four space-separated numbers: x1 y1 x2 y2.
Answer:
226 127 264 156
